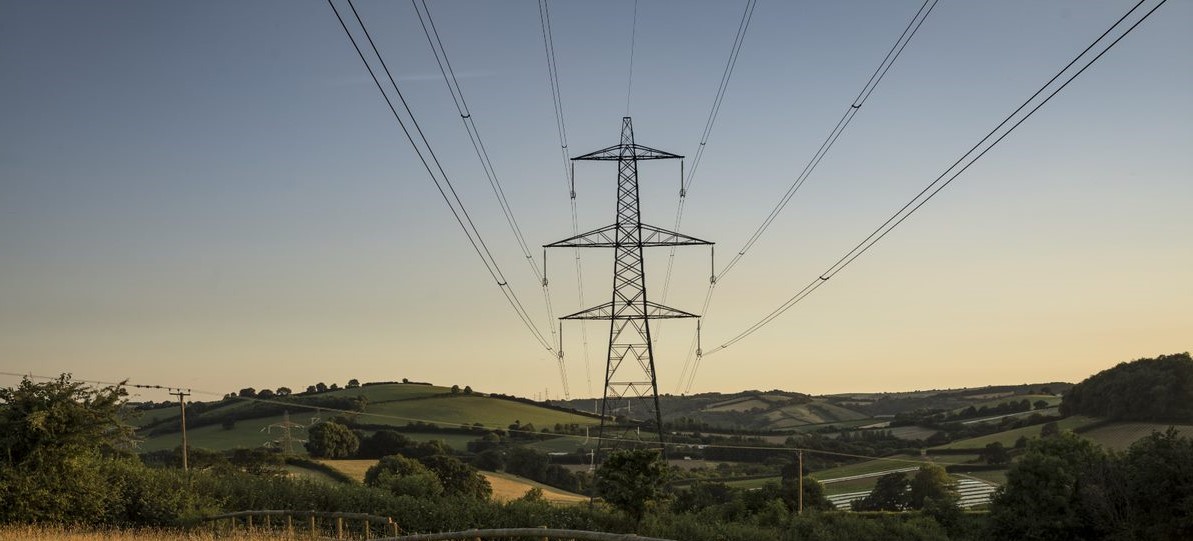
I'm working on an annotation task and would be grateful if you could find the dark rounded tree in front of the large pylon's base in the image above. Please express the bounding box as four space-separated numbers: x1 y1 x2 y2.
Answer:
597 449 668 522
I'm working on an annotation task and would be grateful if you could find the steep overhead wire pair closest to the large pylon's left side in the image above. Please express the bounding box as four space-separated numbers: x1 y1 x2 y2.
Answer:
538 0 593 394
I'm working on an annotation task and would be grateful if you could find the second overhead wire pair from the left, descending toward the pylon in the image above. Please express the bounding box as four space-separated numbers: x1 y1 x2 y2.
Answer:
410 0 571 398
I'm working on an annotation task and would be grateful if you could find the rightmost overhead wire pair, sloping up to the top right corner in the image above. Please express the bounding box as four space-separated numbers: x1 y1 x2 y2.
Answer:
706 0 1168 363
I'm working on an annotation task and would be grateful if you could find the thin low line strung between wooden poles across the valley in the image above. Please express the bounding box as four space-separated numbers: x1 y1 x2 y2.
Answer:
0 371 934 465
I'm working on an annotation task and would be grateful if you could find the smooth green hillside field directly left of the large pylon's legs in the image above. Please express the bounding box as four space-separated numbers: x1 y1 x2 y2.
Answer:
357 395 600 430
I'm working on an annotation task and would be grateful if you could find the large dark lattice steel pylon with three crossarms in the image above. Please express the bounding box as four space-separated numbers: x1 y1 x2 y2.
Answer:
544 117 712 460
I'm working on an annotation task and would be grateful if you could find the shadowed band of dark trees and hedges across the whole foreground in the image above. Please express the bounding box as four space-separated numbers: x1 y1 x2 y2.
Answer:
0 355 1193 541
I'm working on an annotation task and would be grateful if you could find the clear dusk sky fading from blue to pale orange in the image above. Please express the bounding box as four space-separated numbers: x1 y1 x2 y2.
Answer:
0 0 1193 400
